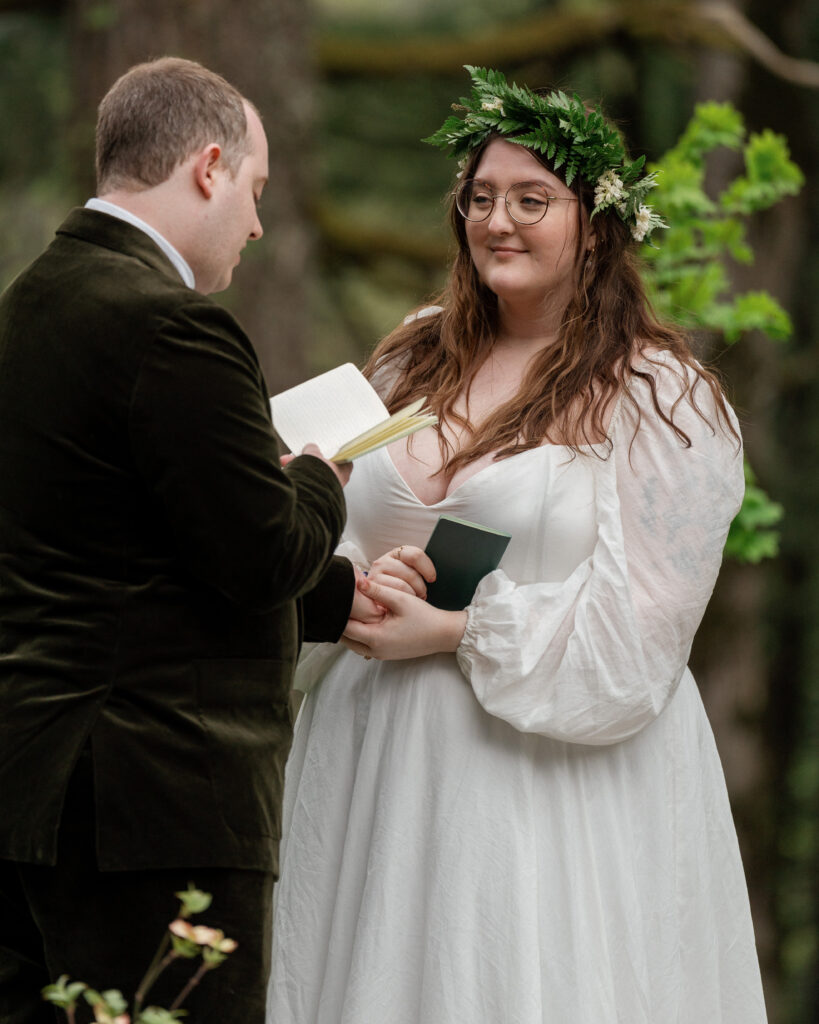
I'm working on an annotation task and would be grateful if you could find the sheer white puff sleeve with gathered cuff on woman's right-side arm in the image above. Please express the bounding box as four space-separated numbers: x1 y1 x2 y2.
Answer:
457 355 743 744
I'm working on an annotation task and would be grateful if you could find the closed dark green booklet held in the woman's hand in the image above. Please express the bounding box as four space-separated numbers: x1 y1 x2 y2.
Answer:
424 515 511 611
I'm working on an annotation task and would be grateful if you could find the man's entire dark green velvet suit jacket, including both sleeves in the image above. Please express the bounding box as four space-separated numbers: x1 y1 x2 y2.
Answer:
0 210 353 870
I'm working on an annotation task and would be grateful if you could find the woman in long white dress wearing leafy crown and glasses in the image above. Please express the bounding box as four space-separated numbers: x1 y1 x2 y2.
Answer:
268 69 766 1024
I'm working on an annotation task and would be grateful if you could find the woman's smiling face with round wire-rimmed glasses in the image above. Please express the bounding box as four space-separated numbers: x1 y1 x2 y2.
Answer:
465 139 594 307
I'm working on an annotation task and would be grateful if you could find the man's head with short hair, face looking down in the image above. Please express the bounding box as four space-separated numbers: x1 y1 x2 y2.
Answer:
96 57 267 293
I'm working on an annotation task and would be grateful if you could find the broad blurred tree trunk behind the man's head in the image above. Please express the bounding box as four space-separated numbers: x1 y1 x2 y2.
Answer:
68 0 315 392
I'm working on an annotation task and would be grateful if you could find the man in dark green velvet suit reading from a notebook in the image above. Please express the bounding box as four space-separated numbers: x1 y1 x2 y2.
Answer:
0 58 354 1024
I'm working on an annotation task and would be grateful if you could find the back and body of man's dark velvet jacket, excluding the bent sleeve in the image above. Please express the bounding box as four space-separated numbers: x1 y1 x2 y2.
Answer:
0 210 297 867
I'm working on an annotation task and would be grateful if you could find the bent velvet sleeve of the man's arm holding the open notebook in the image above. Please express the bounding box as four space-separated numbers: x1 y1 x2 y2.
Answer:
129 293 345 611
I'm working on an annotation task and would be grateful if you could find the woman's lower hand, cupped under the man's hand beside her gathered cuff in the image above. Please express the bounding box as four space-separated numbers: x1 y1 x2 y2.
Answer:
341 578 467 662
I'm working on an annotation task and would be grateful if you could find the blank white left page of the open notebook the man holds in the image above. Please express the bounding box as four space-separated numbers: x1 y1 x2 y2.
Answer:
270 362 389 459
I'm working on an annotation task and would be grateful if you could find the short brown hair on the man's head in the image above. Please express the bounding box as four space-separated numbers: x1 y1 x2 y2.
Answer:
96 57 253 195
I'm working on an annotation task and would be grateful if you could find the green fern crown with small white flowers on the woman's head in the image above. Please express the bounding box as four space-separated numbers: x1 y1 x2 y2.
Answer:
424 65 667 242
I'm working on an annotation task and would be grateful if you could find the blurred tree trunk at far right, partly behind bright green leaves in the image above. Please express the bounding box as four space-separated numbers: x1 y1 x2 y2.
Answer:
694 2 816 1024
